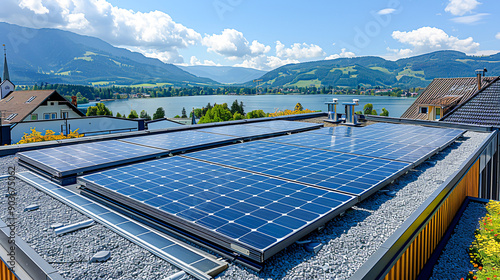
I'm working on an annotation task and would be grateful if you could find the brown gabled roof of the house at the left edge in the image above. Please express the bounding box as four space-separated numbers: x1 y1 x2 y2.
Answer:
0 90 84 123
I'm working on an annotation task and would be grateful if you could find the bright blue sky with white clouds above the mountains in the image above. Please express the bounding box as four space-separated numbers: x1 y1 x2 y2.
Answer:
0 0 500 70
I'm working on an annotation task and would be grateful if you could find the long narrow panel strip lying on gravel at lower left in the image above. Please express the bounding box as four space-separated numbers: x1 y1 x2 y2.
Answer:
18 172 227 279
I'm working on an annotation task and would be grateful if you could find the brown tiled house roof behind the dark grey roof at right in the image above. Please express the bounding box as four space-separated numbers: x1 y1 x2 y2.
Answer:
401 77 495 120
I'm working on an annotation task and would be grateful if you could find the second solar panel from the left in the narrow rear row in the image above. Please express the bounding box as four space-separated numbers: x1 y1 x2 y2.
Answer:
120 130 238 152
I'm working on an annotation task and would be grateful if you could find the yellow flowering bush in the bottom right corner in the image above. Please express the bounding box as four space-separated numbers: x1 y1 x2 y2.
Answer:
467 201 500 280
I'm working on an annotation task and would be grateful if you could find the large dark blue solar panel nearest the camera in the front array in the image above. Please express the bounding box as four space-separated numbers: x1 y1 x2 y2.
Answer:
78 157 356 262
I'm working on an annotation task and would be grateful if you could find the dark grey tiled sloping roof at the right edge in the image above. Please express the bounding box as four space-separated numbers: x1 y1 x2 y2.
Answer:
441 77 500 126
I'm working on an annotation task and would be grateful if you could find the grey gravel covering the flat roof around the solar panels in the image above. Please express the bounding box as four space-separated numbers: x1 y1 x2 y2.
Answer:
0 132 488 280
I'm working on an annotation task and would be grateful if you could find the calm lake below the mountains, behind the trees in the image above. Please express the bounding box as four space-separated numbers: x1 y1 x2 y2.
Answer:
99 94 415 118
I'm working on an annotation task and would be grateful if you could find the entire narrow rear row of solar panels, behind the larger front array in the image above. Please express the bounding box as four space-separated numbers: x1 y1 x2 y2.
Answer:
18 121 322 184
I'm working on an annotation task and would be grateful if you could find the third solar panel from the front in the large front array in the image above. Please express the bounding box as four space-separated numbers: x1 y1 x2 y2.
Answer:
266 133 437 163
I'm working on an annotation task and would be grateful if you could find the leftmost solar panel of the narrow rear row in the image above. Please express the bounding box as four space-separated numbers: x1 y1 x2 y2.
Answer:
17 140 168 177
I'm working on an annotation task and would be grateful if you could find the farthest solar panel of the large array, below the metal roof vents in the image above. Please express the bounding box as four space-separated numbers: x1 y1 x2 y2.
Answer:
310 123 465 148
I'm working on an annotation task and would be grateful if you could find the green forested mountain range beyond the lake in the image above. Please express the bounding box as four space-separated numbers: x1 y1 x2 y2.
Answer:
0 23 500 88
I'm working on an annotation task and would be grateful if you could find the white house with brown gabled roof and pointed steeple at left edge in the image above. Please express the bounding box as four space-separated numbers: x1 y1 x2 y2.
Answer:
0 47 85 124
